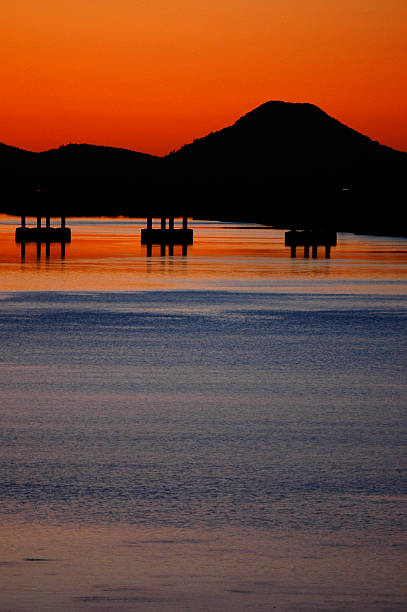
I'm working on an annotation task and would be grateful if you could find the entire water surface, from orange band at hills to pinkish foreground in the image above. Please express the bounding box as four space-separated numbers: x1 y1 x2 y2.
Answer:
0 217 407 612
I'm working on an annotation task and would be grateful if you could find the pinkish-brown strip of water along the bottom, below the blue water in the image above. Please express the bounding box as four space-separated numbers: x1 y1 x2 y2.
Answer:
0 521 407 612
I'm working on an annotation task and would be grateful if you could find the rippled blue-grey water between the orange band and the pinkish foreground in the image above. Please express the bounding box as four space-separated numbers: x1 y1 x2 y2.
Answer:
0 291 407 537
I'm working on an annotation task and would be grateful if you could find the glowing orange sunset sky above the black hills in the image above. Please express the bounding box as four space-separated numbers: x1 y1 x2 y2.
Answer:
0 0 407 154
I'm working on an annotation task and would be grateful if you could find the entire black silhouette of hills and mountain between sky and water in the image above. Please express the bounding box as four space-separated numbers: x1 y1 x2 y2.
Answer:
0 102 407 235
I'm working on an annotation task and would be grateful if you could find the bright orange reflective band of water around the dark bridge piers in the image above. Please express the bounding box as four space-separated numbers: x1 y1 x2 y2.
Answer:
0 215 407 294
